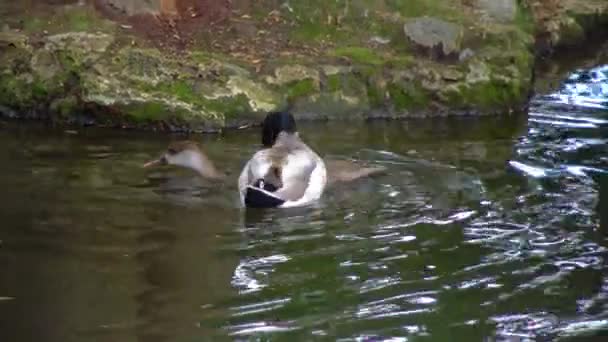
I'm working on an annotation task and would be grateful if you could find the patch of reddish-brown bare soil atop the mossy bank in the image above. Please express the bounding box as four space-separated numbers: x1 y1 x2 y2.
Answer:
94 0 326 64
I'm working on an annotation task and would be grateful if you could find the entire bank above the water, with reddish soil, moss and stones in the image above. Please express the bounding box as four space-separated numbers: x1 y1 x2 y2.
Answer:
0 0 608 131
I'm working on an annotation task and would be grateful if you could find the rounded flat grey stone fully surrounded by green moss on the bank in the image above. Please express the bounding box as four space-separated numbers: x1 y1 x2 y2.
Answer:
403 17 463 57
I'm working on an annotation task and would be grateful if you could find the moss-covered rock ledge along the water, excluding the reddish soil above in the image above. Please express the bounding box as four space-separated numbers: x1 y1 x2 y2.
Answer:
0 0 548 130
